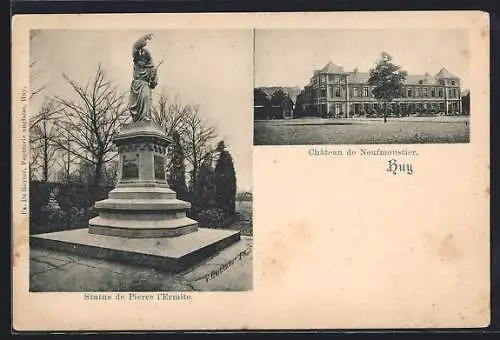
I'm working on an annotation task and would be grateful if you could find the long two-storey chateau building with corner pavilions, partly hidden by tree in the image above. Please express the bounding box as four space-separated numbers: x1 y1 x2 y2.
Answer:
297 61 462 117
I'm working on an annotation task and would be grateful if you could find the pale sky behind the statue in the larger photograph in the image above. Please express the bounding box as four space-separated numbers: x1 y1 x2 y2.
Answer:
30 29 253 191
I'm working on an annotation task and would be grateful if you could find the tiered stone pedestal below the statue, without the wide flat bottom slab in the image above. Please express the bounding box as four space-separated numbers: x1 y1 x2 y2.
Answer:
89 121 198 238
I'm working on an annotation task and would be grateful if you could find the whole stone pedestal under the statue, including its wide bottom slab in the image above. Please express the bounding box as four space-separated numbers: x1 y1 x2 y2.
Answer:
30 122 240 272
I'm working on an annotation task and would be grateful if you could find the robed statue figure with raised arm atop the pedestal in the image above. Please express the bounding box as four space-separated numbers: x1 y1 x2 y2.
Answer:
129 34 159 122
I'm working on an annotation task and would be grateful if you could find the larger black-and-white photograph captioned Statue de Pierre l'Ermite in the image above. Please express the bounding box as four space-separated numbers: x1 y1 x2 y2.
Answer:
29 30 253 292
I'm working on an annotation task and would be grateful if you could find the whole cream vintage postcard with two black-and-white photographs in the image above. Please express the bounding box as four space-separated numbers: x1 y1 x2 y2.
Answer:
11 11 490 331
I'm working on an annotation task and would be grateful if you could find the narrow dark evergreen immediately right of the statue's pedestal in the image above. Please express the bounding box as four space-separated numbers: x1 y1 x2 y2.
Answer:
167 131 187 200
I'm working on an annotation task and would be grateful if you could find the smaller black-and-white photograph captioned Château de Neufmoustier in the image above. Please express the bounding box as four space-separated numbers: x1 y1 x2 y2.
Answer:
254 28 471 145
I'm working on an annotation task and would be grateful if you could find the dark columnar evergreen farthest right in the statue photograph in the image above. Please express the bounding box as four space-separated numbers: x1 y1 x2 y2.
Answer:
215 141 236 216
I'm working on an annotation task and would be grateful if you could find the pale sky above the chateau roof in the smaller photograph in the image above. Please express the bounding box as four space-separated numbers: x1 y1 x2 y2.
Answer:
255 29 470 89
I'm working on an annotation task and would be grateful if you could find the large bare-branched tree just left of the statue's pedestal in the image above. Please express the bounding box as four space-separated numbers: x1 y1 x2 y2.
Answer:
55 64 128 185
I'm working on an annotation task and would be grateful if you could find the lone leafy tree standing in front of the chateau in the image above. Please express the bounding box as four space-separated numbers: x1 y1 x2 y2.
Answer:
368 52 407 122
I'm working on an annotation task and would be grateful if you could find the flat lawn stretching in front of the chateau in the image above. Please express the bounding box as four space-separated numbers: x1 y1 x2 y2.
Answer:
254 117 469 145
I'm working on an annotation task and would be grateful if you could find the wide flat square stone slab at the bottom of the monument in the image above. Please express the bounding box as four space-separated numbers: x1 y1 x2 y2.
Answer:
30 228 240 272
